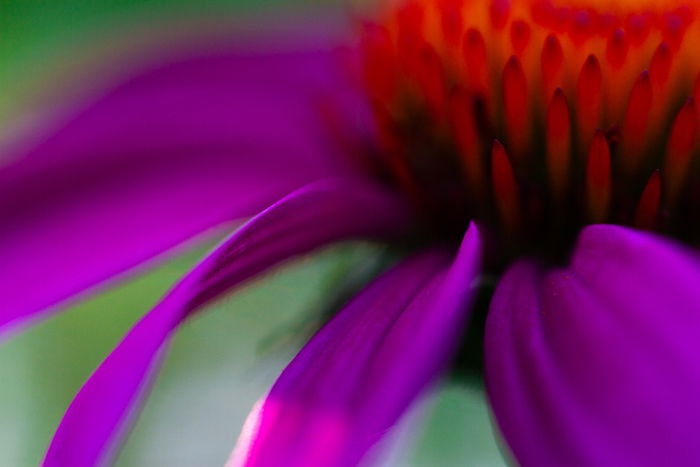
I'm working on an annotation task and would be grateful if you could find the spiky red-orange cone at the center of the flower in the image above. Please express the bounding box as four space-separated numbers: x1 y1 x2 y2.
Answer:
361 0 700 261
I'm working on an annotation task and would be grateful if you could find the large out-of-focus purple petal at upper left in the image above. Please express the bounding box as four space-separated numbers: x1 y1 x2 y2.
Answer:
0 43 356 328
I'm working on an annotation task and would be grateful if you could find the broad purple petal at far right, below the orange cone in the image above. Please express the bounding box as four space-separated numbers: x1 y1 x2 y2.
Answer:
486 225 700 466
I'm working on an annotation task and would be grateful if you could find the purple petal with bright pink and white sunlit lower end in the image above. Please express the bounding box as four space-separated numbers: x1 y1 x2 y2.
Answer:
231 226 481 466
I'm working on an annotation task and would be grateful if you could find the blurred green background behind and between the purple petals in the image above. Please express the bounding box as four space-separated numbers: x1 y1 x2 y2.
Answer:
0 0 504 467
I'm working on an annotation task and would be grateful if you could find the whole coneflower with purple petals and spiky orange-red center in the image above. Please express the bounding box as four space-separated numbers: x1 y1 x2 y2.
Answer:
0 0 700 466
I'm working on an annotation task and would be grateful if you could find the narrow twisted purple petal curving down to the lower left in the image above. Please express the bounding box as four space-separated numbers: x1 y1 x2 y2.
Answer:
45 179 407 466
